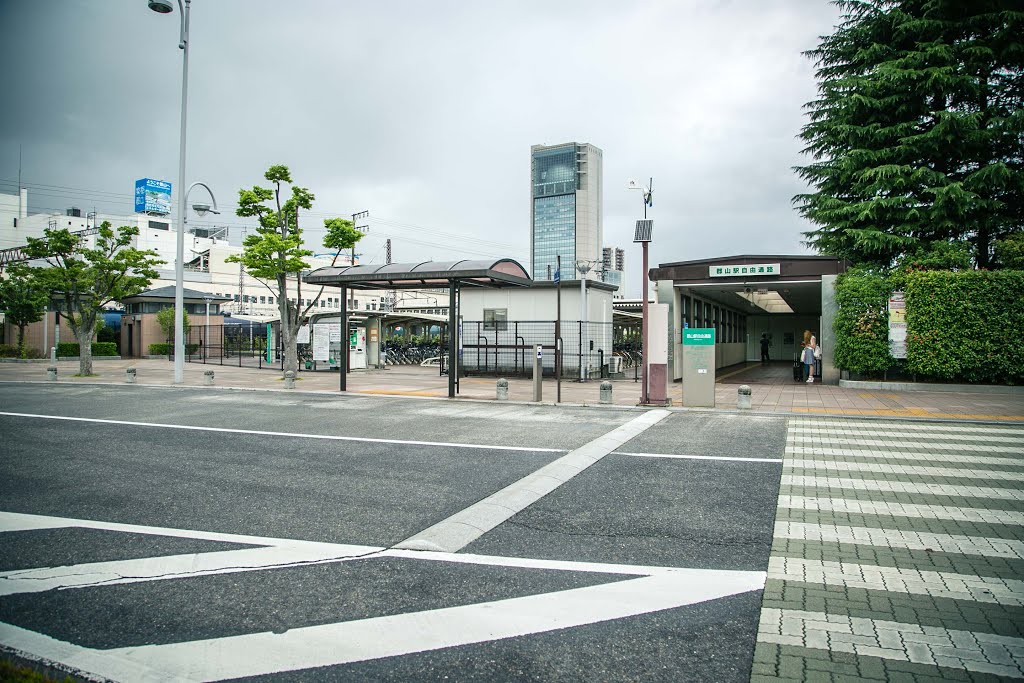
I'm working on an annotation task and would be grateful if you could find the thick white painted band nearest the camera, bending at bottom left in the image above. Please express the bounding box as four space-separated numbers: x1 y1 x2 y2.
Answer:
0 570 765 681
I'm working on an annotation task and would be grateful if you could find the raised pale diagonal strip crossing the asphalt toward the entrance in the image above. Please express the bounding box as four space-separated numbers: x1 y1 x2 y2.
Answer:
395 410 671 553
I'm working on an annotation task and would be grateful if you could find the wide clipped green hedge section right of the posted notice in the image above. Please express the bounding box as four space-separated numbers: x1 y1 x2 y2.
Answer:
904 270 1024 384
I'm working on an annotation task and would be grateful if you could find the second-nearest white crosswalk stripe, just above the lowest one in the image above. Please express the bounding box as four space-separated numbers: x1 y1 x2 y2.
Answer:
768 557 1024 606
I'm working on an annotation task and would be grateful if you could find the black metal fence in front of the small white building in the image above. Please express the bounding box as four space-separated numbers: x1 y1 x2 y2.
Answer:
462 321 623 379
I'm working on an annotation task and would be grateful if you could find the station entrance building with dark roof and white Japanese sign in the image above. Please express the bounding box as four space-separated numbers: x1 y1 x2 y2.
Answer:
650 255 848 383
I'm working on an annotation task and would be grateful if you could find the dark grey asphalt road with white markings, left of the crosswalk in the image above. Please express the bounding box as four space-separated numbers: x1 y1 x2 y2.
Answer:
0 383 785 681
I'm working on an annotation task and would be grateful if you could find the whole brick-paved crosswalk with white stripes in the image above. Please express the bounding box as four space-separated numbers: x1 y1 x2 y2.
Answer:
752 418 1024 683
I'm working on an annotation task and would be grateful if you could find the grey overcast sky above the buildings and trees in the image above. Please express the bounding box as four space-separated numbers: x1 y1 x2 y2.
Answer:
0 0 839 296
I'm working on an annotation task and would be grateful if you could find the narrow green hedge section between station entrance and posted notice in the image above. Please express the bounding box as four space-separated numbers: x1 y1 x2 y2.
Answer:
833 270 893 375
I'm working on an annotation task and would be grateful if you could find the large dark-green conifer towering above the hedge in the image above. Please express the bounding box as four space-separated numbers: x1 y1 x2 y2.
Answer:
794 0 1024 267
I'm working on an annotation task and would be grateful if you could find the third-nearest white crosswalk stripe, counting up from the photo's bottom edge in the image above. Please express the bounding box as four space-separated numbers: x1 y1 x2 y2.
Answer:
775 520 1024 559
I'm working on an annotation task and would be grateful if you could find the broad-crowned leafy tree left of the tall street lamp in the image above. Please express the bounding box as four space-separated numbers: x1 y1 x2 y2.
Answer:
24 220 164 376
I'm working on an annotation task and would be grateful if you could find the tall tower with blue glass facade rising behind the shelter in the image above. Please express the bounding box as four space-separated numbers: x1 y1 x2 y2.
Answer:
529 142 604 280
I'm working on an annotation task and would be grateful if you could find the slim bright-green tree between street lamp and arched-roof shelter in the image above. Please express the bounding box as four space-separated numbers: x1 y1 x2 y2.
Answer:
225 165 361 372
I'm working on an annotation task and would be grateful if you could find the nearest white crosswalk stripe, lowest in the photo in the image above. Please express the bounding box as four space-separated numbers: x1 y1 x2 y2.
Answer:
758 608 1024 678
